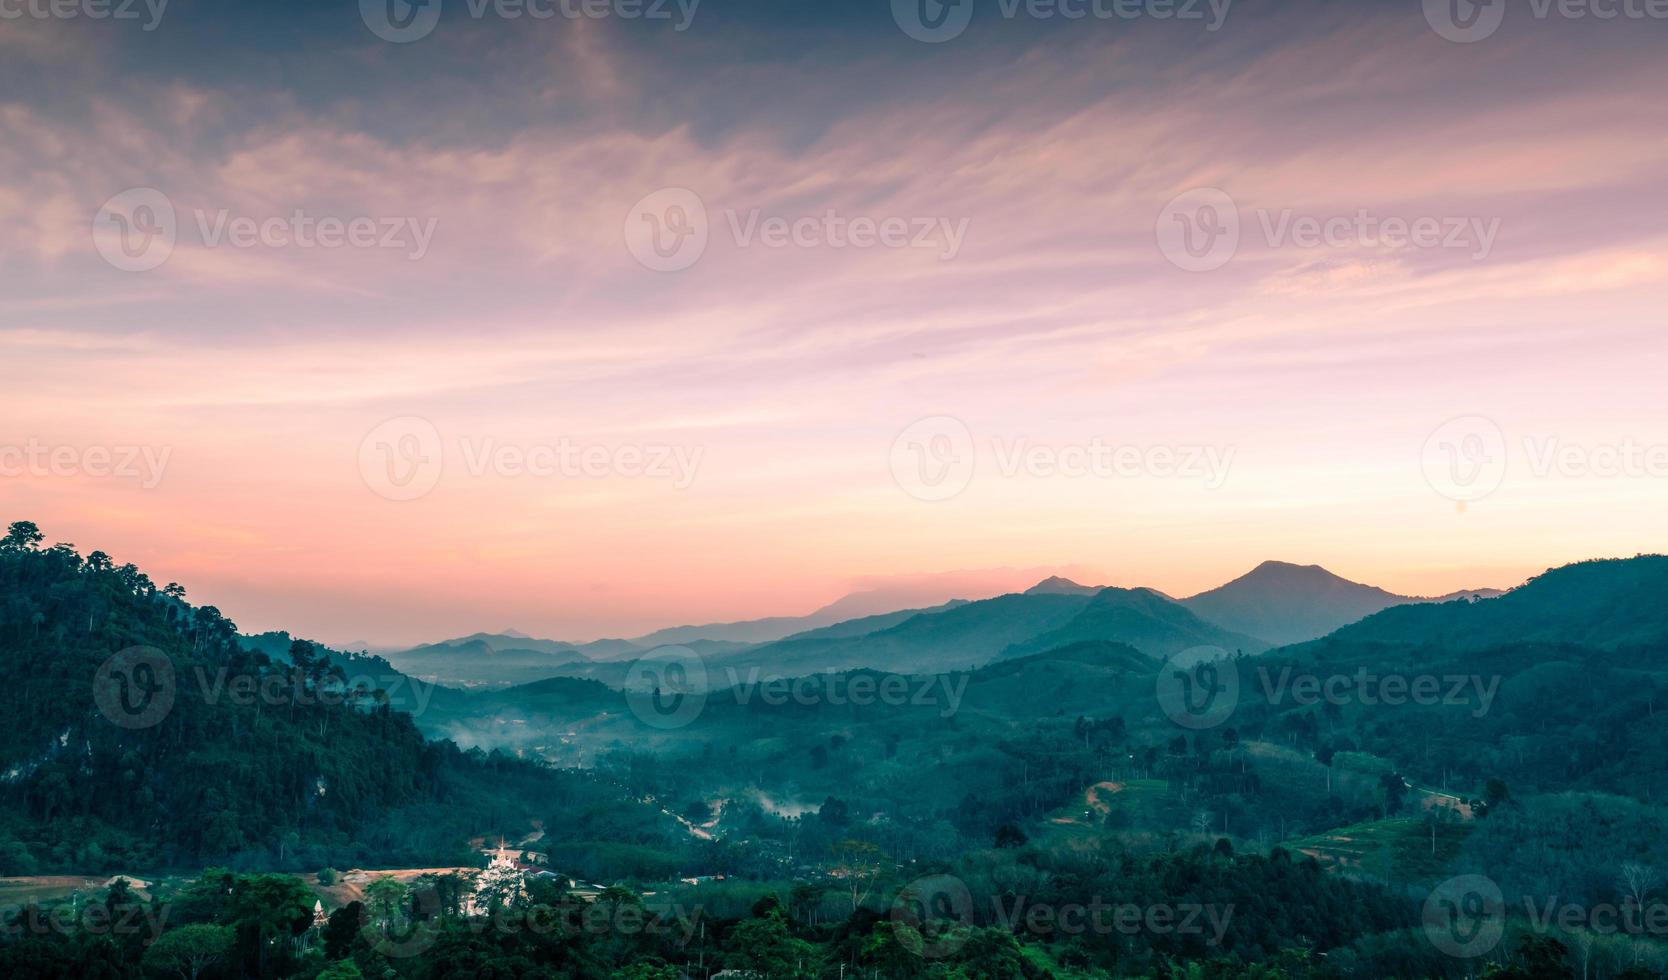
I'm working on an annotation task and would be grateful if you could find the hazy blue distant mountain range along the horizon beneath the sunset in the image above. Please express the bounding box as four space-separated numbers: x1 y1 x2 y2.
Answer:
387 562 1500 687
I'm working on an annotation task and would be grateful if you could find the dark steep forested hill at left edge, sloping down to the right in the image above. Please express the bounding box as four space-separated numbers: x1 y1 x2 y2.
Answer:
0 523 595 875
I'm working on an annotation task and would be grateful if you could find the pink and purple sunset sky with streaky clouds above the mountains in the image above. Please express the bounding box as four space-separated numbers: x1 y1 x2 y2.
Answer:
0 0 1668 643
